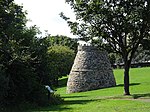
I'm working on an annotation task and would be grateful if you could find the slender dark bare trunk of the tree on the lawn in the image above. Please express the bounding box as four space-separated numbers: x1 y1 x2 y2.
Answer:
124 61 130 95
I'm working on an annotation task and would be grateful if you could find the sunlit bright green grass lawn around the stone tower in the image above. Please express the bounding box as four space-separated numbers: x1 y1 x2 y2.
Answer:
32 67 150 112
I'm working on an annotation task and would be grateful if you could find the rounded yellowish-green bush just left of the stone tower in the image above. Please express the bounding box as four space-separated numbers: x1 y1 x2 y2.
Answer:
48 45 75 85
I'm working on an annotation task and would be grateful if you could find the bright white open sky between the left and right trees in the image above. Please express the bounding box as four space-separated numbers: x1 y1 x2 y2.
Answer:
15 0 75 38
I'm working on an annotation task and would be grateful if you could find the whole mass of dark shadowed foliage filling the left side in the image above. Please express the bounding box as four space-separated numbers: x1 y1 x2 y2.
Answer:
0 0 63 109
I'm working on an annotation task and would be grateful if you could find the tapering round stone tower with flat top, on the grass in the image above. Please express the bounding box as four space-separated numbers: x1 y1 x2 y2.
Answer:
67 46 116 93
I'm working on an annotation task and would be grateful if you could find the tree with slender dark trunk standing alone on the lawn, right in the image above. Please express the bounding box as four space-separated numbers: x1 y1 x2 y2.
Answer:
61 0 150 95
